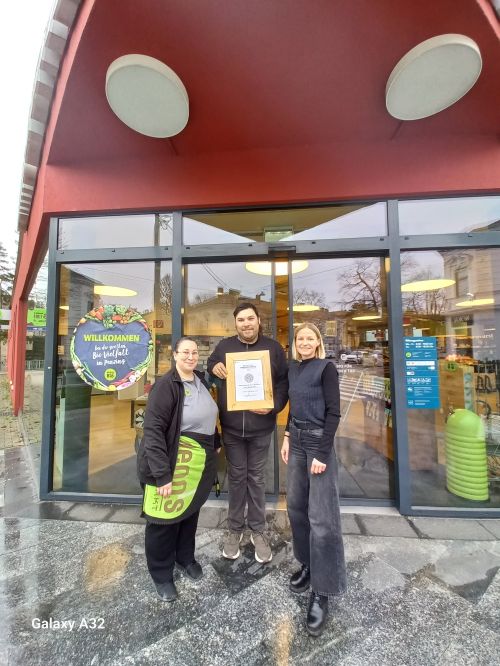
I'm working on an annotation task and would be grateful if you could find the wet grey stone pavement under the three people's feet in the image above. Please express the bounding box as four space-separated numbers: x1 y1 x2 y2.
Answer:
0 390 500 666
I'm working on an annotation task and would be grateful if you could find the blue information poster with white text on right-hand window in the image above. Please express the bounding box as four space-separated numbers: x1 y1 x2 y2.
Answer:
404 337 440 409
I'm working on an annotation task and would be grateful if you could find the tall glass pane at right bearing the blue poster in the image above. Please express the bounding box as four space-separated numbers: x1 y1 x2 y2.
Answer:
402 248 500 508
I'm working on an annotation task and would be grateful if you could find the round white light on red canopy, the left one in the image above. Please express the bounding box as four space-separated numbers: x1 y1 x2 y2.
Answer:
106 53 189 139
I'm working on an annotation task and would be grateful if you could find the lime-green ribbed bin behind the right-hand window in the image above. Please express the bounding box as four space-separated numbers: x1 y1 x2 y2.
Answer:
445 409 489 502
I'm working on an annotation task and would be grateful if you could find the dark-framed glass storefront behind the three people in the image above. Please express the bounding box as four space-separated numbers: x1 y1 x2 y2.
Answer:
33 192 500 516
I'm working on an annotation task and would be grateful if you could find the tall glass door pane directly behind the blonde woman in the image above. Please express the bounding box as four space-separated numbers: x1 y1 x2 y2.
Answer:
292 257 394 499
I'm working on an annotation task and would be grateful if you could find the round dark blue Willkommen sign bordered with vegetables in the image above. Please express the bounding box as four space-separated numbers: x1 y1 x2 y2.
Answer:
70 305 153 391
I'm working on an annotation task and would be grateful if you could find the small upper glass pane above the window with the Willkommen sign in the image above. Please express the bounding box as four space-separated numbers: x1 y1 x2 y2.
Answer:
57 213 173 250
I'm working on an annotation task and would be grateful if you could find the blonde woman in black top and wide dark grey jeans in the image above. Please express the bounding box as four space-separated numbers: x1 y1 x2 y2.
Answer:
281 322 346 636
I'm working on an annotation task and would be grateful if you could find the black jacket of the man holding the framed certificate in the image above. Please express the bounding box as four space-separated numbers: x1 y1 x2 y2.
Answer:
207 335 288 437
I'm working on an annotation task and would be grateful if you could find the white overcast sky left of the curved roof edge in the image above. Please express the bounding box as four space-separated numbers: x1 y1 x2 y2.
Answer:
0 0 55 256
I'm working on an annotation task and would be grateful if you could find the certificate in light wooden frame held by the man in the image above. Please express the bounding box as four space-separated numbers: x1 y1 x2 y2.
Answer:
226 349 274 412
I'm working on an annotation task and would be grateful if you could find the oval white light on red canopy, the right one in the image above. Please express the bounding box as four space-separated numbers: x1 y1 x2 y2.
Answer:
385 34 482 120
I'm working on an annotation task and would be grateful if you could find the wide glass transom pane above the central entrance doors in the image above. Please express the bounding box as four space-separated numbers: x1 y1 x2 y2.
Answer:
183 203 387 245
